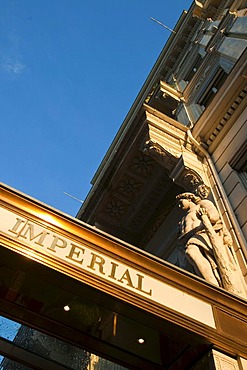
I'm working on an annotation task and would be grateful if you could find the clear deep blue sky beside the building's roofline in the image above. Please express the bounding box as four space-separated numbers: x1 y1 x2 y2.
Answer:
0 0 191 216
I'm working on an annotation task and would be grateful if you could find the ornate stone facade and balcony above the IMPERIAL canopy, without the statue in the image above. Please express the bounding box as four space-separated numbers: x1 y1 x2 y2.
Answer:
78 1 247 292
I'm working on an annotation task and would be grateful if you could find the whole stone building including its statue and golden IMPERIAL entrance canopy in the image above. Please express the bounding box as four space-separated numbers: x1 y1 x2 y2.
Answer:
0 0 247 370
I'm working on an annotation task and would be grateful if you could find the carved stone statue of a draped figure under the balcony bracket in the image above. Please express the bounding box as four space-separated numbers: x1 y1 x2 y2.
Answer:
177 191 247 298
